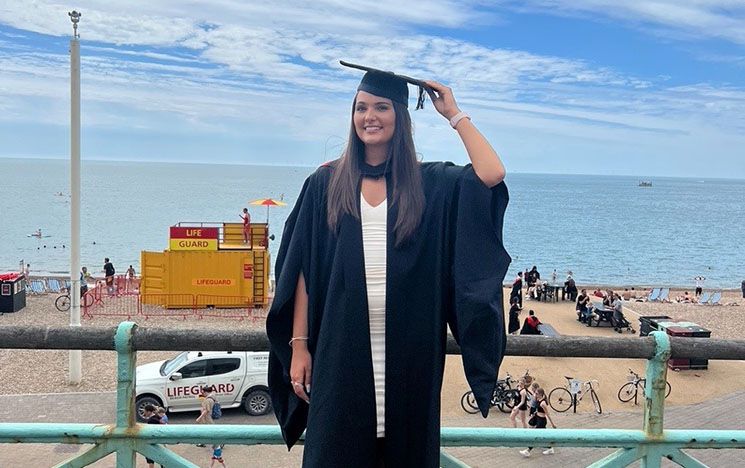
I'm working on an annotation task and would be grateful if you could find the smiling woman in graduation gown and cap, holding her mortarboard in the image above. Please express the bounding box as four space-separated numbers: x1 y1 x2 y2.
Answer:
267 62 510 468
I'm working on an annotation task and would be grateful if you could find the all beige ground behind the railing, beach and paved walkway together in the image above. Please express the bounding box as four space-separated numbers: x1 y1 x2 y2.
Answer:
0 292 745 468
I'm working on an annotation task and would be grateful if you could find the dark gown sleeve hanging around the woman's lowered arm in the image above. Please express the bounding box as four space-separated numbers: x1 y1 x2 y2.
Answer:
266 176 315 448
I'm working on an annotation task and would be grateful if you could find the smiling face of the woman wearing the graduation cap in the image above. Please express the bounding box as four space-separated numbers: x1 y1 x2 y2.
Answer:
353 91 396 147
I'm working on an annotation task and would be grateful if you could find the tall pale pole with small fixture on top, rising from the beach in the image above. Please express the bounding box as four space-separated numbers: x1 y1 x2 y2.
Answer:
67 10 83 385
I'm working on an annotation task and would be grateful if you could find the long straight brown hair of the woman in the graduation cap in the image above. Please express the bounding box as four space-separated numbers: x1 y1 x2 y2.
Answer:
327 97 424 246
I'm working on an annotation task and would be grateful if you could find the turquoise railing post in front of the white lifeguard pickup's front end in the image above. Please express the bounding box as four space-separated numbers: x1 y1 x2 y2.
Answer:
114 322 137 468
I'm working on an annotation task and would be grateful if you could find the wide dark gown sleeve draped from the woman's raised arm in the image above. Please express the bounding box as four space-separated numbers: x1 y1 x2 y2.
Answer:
446 165 512 417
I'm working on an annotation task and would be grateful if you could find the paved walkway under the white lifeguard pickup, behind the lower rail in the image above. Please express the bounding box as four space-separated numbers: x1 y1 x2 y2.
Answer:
0 392 745 468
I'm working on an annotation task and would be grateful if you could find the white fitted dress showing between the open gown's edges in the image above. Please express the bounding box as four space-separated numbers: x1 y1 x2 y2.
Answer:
360 194 388 437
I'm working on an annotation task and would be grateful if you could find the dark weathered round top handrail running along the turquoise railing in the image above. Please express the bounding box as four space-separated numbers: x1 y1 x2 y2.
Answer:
0 326 745 360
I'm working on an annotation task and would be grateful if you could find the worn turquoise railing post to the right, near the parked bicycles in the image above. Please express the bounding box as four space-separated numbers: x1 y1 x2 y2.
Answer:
644 331 670 439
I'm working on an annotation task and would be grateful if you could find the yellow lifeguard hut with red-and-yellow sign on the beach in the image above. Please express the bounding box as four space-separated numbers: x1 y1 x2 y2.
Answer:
140 222 269 308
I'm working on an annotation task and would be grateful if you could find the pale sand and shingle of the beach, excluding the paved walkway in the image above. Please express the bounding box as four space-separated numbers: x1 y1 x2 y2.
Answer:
0 291 745 418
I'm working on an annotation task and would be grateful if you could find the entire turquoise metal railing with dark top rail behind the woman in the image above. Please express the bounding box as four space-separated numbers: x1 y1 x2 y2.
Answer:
0 322 745 468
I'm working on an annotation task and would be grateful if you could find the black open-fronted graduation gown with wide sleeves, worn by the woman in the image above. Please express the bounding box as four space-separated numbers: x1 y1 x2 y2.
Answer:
267 162 511 467
